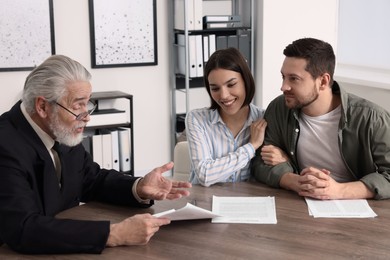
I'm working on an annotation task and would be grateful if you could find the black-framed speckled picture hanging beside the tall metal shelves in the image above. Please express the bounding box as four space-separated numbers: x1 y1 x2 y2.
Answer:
89 0 157 68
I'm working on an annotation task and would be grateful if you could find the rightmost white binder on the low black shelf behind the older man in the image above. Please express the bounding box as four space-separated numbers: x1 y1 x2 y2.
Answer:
118 127 131 172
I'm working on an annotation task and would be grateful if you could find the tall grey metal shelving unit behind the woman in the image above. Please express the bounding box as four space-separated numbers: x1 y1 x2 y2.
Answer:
169 0 255 158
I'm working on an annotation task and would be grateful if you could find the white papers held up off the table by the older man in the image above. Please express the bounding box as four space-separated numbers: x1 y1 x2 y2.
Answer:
153 203 219 220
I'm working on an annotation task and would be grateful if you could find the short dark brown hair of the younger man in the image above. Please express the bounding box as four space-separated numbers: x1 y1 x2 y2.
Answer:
283 38 336 86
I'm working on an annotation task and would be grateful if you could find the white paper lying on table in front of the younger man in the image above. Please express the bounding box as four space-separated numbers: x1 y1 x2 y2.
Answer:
305 198 377 218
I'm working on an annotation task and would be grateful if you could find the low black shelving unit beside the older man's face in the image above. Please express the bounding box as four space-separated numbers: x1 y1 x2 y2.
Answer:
86 91 134 176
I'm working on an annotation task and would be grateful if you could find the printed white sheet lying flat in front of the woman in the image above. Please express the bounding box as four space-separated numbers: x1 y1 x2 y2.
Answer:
211 196 277 224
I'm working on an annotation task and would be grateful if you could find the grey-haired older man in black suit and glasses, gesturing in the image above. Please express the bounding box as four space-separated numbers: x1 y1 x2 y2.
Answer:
0 55 191 254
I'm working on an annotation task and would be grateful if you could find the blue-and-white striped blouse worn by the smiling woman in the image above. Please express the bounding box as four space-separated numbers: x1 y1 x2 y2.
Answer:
186 104 264 186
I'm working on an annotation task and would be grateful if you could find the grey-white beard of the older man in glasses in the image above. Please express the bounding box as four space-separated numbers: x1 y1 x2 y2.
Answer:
49 113 85 147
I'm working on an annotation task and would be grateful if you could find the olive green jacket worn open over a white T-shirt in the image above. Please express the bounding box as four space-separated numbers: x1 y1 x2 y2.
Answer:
251 82 390 199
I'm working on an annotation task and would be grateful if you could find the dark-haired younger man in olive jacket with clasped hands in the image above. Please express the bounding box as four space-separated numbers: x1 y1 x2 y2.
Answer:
252 38 390 199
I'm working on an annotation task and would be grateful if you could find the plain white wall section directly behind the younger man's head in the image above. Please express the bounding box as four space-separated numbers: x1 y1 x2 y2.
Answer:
255 0 338 108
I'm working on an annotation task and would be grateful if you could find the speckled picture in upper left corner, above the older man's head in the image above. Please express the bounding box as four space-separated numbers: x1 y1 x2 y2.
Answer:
0 0 55 71
